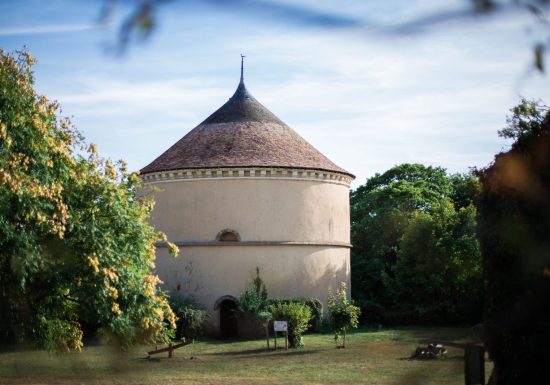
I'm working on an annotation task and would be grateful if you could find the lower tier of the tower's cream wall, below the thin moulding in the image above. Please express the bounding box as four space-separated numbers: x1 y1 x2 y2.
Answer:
156 244 350 335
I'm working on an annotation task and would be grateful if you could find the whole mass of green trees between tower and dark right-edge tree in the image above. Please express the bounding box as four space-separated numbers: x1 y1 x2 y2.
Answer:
351 164 483 323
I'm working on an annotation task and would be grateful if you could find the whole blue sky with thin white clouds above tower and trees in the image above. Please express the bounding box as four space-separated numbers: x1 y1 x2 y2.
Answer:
0 0 550 187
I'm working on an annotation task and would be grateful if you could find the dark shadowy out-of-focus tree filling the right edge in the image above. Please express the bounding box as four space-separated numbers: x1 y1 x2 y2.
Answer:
478 100 550 385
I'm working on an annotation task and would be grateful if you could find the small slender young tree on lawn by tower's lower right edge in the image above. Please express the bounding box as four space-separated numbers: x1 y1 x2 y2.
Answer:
327 282 361 347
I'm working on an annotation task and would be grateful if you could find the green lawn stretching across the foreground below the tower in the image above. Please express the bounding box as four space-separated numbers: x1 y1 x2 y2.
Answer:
0 328 490 385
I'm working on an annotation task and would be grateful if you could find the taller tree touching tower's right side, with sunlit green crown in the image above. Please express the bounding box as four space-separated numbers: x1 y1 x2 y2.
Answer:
350 164 450 314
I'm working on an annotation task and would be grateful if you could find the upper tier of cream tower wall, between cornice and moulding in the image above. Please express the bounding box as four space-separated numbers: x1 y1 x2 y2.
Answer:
144 178 350 243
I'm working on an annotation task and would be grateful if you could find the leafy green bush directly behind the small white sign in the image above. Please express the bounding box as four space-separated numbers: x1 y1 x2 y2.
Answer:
269 302 312 348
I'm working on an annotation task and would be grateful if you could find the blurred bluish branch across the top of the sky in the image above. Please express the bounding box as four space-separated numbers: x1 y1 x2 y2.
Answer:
99 0 550 73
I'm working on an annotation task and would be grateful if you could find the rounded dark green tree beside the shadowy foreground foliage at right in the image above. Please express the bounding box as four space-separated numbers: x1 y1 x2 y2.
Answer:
384 200 483 323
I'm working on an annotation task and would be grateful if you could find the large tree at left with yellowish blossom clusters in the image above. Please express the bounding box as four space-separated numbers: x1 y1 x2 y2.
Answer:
0 50 177 351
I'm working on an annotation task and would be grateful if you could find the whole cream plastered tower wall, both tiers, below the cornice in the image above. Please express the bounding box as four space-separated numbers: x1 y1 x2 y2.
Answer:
142 172 350 328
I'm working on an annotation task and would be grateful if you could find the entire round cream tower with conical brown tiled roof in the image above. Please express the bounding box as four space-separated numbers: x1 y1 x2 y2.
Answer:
141 67 354 335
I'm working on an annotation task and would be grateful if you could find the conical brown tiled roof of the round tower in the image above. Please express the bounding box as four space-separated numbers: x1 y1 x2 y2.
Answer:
141 75 353 177
